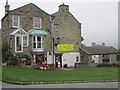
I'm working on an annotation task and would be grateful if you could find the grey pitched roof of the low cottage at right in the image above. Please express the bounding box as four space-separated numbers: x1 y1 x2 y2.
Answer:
83 45 118 55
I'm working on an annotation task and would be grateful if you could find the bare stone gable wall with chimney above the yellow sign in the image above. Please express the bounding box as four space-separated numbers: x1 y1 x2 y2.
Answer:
53 5 81 52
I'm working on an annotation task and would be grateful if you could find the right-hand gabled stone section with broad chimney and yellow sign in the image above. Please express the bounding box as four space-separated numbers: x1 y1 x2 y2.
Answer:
52 3 81 67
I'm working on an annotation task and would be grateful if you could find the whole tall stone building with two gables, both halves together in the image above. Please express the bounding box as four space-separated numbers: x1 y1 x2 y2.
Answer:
1 2 81 67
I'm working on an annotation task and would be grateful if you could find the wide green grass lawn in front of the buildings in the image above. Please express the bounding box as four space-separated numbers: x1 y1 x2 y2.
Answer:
2 66 118 82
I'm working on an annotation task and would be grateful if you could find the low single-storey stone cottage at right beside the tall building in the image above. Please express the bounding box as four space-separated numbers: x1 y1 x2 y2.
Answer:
81 43 118 66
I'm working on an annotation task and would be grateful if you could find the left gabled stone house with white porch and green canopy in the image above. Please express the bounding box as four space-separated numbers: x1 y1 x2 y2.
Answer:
2 2 51 65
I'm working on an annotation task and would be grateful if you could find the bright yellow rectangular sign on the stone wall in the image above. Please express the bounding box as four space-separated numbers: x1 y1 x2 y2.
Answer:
57 44 74 51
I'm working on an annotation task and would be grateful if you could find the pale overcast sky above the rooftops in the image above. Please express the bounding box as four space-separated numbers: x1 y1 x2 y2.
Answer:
0 0 119 48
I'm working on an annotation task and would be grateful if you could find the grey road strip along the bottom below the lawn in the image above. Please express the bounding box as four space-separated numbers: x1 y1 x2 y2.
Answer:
2 82 118 88
